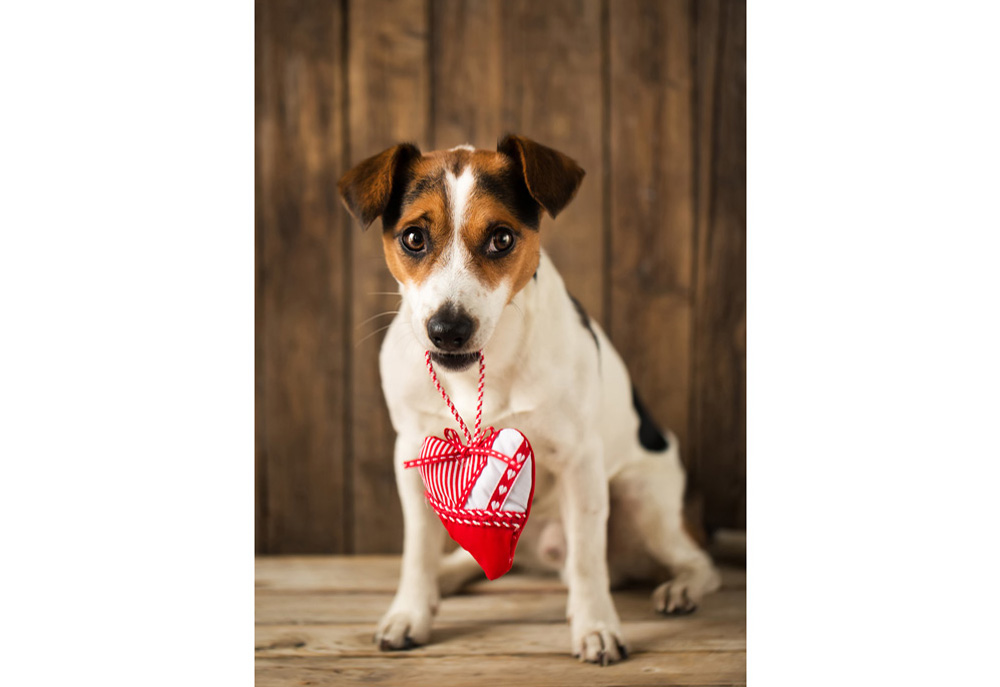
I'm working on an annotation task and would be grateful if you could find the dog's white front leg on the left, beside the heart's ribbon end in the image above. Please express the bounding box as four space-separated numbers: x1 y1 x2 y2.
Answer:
375 436 444 651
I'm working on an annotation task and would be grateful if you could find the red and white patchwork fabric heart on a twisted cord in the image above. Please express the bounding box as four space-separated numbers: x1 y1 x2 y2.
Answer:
403 351 535 580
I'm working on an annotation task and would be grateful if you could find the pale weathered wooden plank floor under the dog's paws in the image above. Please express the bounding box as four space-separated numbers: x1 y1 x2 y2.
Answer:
255 556 746 687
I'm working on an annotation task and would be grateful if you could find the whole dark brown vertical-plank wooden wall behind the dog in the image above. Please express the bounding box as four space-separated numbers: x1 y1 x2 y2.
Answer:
256 0 746 553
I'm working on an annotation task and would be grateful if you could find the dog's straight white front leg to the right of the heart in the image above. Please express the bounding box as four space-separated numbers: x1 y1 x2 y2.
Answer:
559 436 628 665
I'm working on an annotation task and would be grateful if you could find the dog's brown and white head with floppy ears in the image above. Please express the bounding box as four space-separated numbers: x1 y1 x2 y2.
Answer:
339 135 584 369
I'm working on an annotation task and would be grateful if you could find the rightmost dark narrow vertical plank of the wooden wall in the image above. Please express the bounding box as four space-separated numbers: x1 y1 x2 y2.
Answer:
691 0 746 528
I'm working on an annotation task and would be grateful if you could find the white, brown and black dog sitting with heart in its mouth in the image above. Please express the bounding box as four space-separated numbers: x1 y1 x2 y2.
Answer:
338 135 719 665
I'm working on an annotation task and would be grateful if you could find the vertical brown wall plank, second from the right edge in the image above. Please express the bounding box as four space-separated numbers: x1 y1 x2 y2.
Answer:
609 0 694 460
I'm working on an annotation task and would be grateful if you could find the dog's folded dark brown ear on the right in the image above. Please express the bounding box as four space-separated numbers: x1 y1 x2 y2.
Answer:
497 134 585 218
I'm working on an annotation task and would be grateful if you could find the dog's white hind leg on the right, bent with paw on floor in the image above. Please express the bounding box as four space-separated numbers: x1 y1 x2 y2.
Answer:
611 446 720 615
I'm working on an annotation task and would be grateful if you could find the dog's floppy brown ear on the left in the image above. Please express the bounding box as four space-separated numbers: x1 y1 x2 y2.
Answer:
337 143 420 229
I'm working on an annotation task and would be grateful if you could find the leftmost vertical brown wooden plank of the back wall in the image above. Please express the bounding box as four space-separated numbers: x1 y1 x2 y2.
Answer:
256 0 347 552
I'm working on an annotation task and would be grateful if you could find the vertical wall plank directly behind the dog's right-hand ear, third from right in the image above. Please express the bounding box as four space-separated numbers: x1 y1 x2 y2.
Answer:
501 0 606 323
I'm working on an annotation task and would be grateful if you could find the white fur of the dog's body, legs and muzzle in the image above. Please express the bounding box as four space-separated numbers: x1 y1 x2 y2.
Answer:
376 250 719 662
